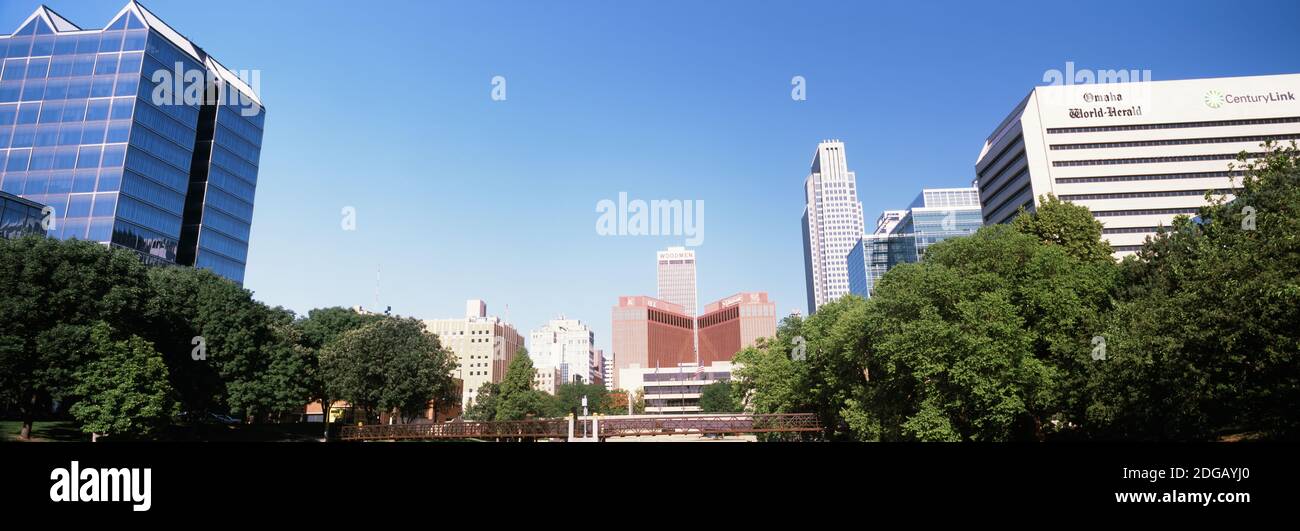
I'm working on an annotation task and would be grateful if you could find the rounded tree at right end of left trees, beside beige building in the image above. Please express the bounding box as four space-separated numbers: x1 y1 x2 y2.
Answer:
320 318 455 420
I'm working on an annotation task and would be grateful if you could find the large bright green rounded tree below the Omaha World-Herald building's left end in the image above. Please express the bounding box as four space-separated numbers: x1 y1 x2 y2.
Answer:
846 226 1117 441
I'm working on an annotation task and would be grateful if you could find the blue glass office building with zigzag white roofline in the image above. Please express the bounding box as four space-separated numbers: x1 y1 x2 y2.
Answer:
0 1 265 282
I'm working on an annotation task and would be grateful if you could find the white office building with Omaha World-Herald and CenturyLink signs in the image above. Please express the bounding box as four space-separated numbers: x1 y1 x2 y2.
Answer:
975 74 1300 258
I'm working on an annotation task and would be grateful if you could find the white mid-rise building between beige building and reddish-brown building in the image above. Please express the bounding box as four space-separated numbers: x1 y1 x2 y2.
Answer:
528 316 602 384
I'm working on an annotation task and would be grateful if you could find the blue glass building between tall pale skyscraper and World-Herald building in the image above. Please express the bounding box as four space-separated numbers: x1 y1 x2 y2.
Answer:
846 187 984 297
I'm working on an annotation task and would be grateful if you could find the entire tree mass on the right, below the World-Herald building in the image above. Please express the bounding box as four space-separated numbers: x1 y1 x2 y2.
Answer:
732 144 1300 441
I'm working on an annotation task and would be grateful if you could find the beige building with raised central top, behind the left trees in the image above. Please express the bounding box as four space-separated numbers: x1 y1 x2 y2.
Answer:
424 299 524 409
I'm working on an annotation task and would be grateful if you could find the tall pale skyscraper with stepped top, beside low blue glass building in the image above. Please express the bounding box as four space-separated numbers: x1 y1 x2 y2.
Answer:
803 141 863 314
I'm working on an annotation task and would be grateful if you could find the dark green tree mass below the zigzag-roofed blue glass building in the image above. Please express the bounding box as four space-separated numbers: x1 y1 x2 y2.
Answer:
0 237 459 437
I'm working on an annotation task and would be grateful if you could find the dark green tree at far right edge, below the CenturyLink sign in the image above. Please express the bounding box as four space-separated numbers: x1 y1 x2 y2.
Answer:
1088 143 1300 440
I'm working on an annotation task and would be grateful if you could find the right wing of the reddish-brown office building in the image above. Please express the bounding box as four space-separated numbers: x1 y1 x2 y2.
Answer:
696 292 776 366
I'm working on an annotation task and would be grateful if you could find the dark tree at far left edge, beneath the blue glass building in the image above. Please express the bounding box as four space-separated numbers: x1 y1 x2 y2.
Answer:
0 236 150 439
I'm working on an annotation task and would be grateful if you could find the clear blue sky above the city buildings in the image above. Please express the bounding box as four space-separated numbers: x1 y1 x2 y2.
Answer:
0 0 1300 347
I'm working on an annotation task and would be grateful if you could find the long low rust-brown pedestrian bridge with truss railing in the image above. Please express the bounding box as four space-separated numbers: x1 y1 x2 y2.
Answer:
339 413 822 441
